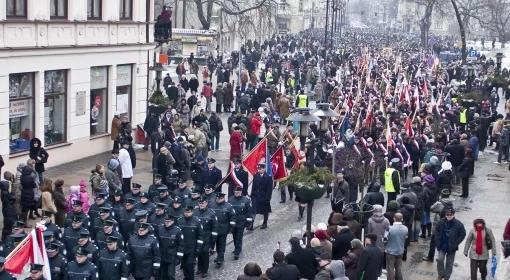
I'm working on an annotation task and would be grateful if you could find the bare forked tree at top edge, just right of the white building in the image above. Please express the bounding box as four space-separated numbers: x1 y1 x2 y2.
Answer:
193 0 276 29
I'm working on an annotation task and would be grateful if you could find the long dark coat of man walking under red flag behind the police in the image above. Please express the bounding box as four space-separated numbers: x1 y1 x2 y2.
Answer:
251 173 273 214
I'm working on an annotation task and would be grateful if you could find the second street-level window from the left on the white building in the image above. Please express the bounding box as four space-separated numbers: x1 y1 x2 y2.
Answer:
44 70 67 145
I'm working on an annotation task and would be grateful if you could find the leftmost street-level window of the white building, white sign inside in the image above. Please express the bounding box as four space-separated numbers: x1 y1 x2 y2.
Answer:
9 73 35 154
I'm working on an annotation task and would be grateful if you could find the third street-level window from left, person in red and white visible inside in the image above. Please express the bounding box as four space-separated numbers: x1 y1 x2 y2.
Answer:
90 66 108 136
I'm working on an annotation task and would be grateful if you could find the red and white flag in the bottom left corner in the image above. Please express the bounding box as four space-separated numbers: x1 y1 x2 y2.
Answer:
4 224 51 280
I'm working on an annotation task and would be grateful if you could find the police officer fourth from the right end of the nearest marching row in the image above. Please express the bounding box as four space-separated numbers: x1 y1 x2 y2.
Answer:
177 206 204 280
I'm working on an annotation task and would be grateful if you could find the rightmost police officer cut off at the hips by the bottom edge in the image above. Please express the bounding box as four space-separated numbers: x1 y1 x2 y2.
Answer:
97 235 129 280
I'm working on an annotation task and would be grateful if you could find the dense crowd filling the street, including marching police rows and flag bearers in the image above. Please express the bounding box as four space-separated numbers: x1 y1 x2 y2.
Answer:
0 26 510 280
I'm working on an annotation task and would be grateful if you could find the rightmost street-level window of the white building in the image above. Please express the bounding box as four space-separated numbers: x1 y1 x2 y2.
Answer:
116 64 133 119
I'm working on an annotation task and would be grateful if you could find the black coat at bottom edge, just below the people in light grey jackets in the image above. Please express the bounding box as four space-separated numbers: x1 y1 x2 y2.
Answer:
356 244 383 280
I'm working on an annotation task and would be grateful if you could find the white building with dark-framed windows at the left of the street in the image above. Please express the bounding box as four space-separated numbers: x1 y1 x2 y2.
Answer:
0 0 154 171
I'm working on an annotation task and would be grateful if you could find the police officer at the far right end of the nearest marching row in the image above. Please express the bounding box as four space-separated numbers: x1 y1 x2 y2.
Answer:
228 186 253 260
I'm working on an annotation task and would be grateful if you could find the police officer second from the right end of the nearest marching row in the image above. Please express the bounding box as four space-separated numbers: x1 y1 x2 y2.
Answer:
211 192 236 267
